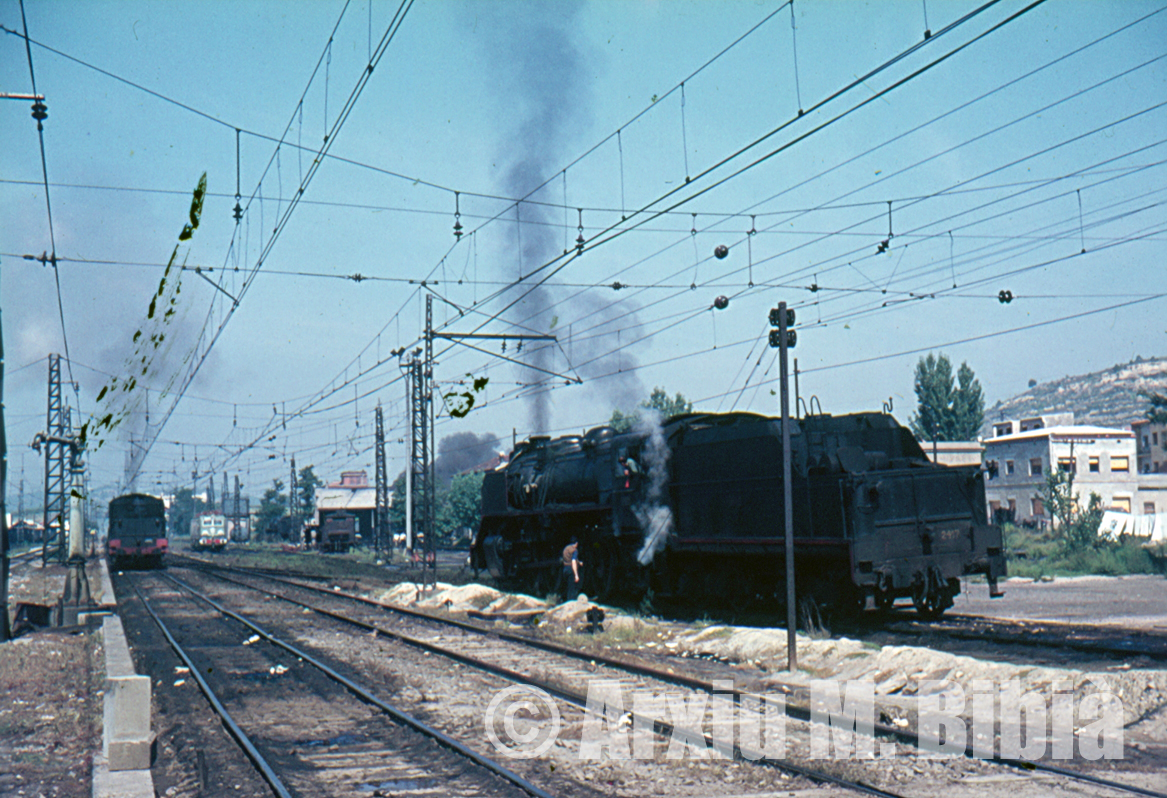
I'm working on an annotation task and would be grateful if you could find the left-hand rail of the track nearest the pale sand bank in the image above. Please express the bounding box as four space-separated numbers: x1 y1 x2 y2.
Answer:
182 564 903 798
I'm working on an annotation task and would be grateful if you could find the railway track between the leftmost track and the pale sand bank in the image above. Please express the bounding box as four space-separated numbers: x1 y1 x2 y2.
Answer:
175 557 1165 798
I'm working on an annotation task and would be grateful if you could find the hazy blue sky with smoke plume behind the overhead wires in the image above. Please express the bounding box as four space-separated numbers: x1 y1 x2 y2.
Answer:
0 0 1167 504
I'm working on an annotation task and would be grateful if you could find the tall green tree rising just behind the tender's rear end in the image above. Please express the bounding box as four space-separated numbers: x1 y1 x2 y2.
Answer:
909 352 985 441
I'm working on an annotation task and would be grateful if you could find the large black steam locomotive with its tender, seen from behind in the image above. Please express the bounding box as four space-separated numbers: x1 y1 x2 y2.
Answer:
471 413 1005 617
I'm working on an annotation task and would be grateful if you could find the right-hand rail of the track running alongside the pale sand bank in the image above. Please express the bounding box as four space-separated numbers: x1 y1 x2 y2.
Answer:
184 564 1167 798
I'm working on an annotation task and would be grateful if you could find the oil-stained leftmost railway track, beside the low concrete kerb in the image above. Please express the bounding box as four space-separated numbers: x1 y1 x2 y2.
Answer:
120 574 553 798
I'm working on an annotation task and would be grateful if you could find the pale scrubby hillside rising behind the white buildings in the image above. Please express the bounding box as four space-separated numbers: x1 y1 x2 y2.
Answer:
980 357 1167 438
